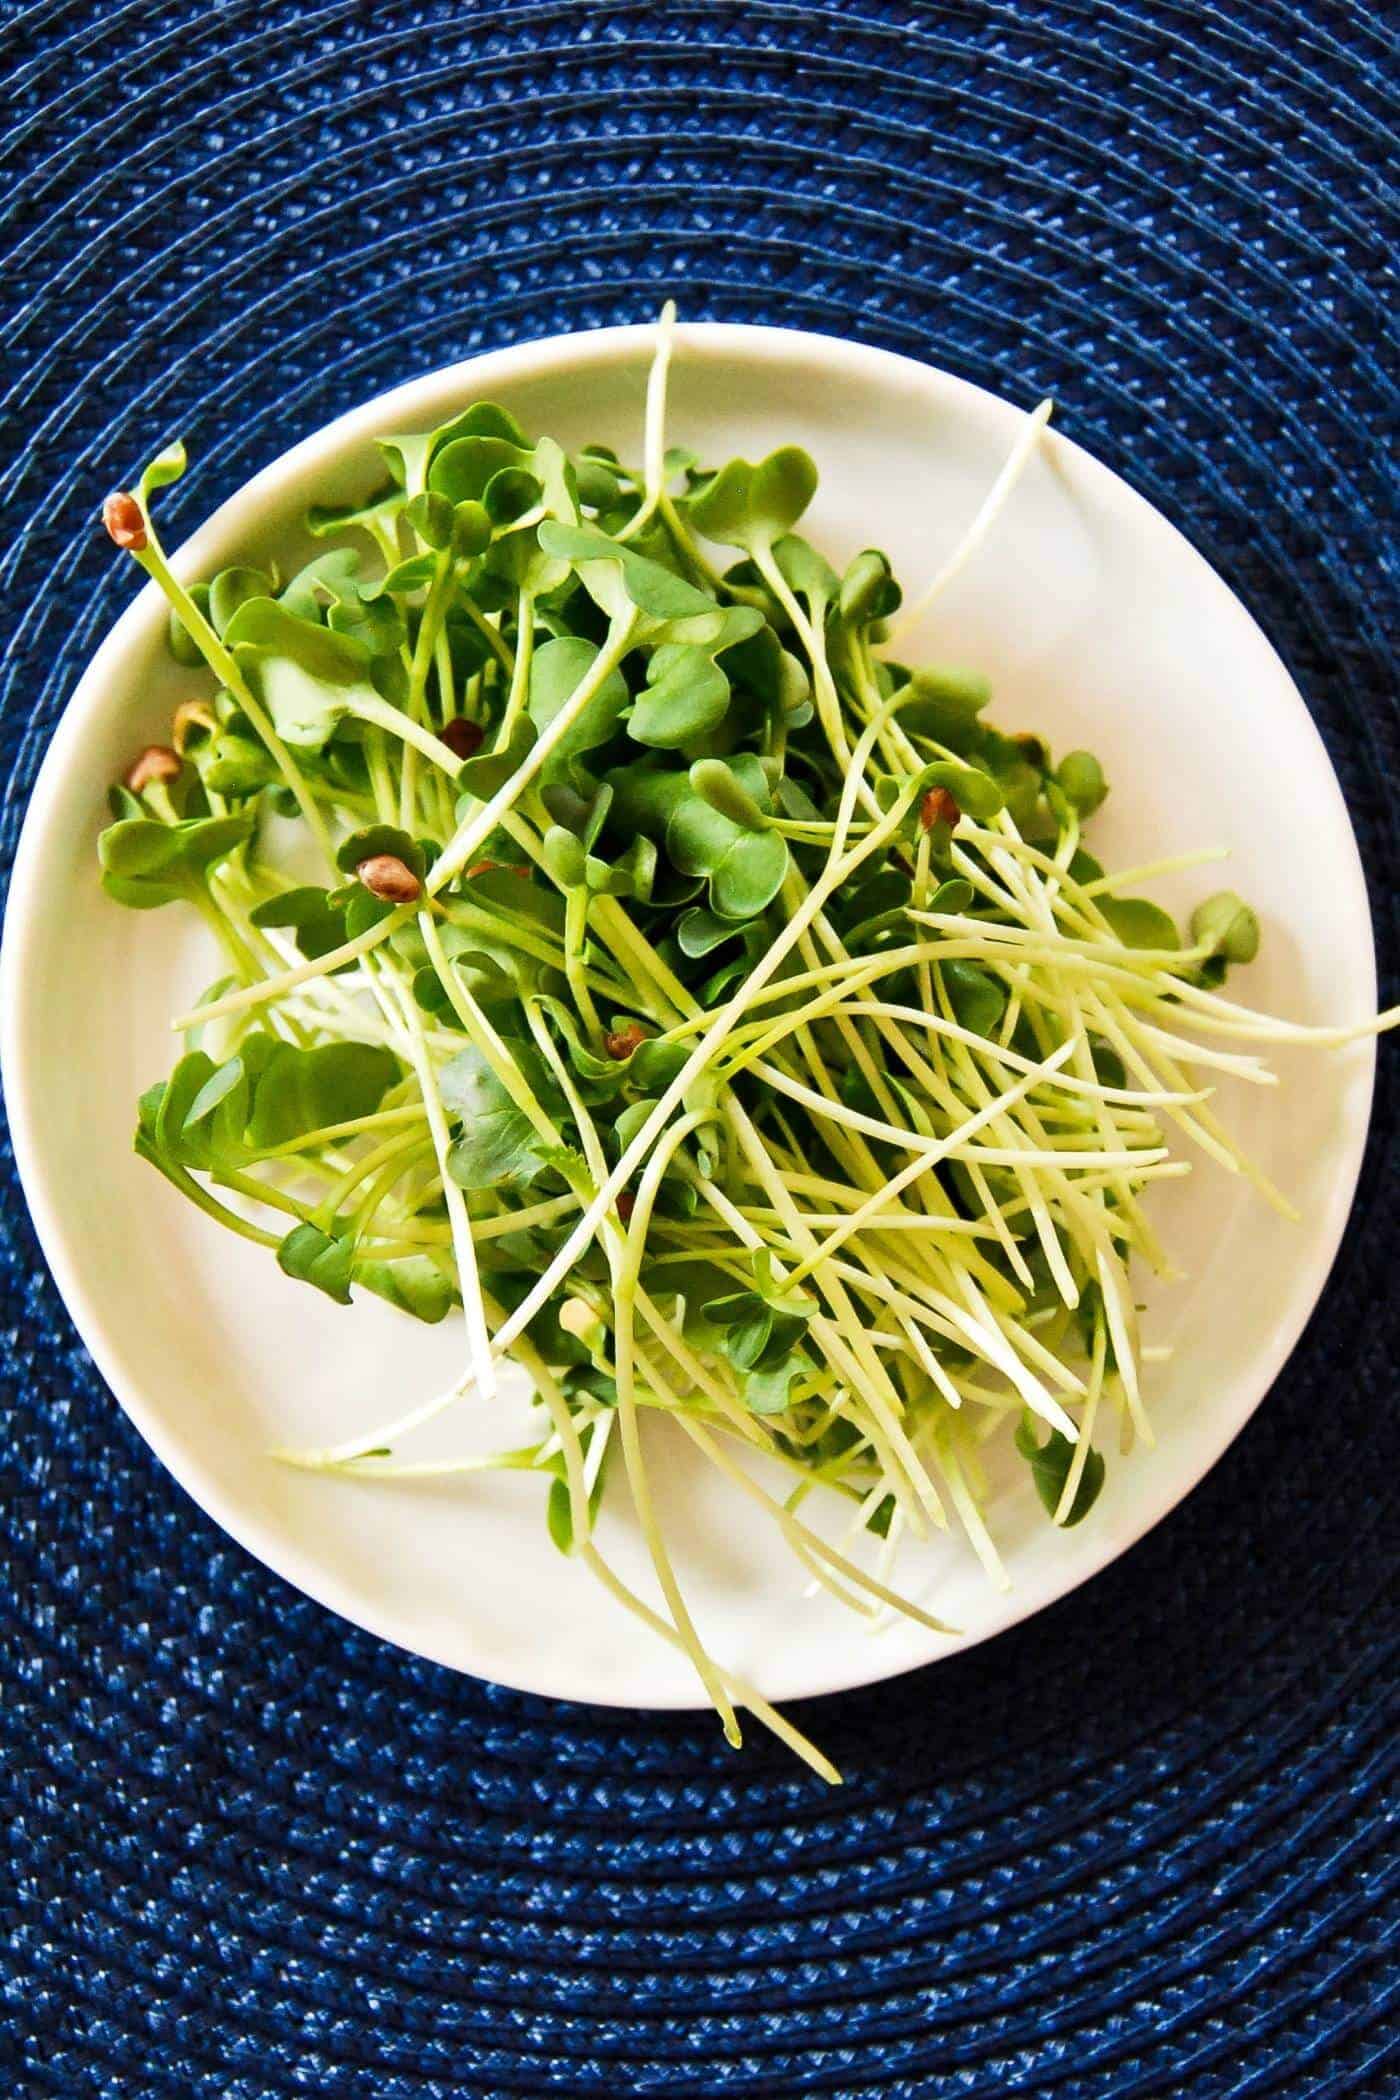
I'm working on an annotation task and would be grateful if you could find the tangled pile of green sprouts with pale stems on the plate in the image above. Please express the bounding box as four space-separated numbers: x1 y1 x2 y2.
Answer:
101 309 1396 1779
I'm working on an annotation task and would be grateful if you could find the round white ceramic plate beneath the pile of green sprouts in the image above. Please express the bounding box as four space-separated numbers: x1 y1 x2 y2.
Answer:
0 326 1375 1707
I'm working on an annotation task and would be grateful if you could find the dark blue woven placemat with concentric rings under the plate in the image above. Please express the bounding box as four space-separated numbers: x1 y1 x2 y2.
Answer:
0 0 1400 2100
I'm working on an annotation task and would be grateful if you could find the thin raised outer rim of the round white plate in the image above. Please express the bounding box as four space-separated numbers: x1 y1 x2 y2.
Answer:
0 321 1377 1712
